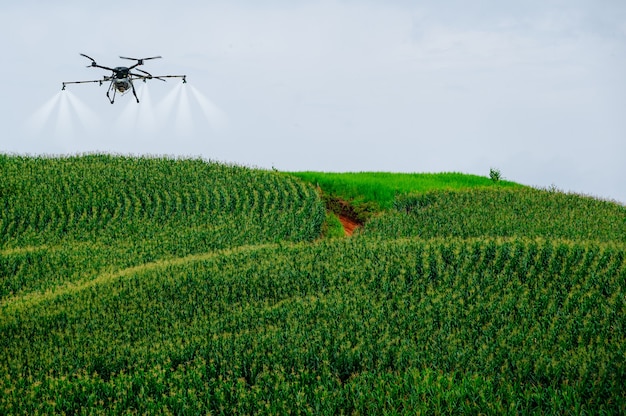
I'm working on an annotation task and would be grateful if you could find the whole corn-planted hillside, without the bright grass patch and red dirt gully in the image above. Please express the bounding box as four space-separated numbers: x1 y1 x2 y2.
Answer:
0 155 626 414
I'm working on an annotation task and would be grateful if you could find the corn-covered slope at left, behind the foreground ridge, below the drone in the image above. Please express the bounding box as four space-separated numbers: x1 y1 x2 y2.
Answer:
0 155 324 299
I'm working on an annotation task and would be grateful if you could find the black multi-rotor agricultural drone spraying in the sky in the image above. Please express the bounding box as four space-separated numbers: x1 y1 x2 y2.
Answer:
61 53 187 104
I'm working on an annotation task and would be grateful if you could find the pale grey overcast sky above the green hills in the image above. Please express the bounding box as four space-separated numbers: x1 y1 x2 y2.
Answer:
0 0 626 202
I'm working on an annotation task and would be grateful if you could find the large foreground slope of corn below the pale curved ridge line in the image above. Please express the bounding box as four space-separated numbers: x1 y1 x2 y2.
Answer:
0 237 626 414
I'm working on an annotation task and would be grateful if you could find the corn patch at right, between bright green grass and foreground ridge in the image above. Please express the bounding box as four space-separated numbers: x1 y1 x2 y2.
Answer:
365 188 626 243
